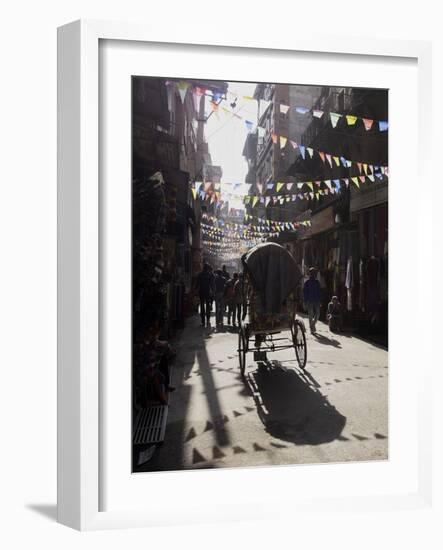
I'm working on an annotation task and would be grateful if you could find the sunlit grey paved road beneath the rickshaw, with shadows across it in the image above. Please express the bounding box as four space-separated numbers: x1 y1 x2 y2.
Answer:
137 316 388 471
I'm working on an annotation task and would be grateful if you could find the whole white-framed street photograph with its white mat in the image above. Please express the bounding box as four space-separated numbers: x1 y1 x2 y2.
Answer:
58 21 432 530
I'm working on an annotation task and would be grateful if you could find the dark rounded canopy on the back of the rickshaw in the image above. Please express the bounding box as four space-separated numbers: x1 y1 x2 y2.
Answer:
242 243 302 313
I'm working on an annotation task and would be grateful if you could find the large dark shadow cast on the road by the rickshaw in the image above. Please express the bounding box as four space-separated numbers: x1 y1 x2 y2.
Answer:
248 363 346 445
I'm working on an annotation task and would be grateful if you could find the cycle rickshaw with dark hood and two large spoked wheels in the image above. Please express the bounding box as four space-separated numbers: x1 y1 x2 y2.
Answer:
238 243 307 376
